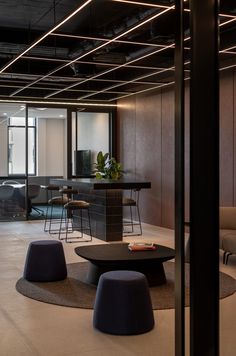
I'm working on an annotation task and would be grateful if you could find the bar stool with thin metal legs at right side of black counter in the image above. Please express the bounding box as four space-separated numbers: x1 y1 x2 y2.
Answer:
122 189 142 236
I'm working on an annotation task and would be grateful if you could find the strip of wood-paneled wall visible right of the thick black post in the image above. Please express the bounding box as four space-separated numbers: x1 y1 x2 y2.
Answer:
220 74 234 206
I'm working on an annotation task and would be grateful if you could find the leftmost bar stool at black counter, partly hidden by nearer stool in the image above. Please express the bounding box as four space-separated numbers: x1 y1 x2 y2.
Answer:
44 185 78 234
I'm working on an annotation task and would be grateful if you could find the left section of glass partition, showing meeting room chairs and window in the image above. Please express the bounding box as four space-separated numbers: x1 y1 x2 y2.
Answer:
0 104 67 221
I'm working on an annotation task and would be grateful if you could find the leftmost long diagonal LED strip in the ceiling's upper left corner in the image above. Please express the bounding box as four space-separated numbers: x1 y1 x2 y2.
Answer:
0 0 92 74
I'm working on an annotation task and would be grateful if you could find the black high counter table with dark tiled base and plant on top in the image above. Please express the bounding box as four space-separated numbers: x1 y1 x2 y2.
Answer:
50 178 151 241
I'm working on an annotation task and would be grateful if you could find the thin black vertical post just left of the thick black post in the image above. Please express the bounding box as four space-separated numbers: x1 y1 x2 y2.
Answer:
175 0 185 356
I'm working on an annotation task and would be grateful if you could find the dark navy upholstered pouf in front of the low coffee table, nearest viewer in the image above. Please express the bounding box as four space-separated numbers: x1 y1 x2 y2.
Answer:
93 271 154 335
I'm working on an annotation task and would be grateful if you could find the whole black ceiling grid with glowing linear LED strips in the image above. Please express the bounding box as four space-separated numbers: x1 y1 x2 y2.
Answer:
0 0 236 101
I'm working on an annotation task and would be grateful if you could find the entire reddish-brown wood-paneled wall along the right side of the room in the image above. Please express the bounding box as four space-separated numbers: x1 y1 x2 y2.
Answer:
118 71 236 228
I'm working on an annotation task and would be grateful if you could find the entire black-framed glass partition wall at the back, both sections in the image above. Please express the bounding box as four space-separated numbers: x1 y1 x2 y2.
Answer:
0 104 113 221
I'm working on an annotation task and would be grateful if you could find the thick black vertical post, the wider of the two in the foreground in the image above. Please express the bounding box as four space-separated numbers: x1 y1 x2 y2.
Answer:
190 0 219 356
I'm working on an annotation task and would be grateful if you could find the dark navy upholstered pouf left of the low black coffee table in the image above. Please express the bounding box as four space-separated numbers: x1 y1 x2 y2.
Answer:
24 240 67 282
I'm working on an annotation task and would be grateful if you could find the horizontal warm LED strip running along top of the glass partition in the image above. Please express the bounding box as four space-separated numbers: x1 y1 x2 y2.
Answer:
0 99 116 107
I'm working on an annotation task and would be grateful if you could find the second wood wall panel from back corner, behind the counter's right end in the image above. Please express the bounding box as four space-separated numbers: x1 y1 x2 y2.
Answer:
136 95 162 225
